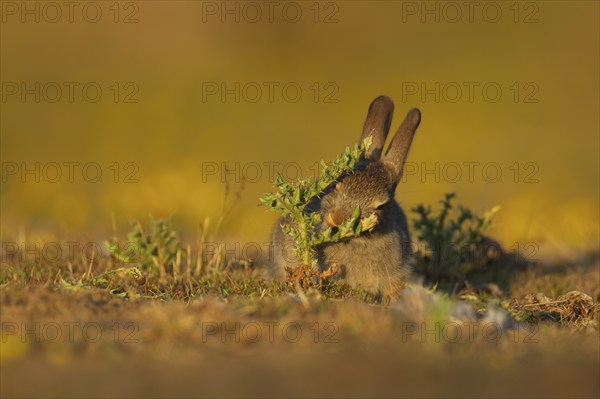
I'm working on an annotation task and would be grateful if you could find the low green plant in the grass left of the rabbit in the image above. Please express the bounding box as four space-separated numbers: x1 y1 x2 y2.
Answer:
105 217 181 276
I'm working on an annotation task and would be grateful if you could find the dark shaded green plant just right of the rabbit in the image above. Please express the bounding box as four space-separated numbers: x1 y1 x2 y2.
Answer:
412 193 500 280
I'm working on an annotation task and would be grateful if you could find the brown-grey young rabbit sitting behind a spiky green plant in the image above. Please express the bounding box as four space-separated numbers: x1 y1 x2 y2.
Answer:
270 96 421 300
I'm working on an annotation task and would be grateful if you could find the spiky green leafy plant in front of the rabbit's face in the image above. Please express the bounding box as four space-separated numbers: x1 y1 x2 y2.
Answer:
260 137 377 269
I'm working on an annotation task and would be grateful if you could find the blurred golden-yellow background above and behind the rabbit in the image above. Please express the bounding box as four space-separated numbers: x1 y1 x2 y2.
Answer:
0 1 600 251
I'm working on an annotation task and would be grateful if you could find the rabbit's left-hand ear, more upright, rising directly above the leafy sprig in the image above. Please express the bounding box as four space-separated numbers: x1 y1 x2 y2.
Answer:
360 96 394 161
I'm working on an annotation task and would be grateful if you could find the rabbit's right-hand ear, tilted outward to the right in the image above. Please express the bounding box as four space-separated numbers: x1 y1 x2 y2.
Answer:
383 108 421 183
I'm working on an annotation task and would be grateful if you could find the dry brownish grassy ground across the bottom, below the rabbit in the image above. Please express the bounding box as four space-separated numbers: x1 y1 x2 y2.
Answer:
0 233 600 397
